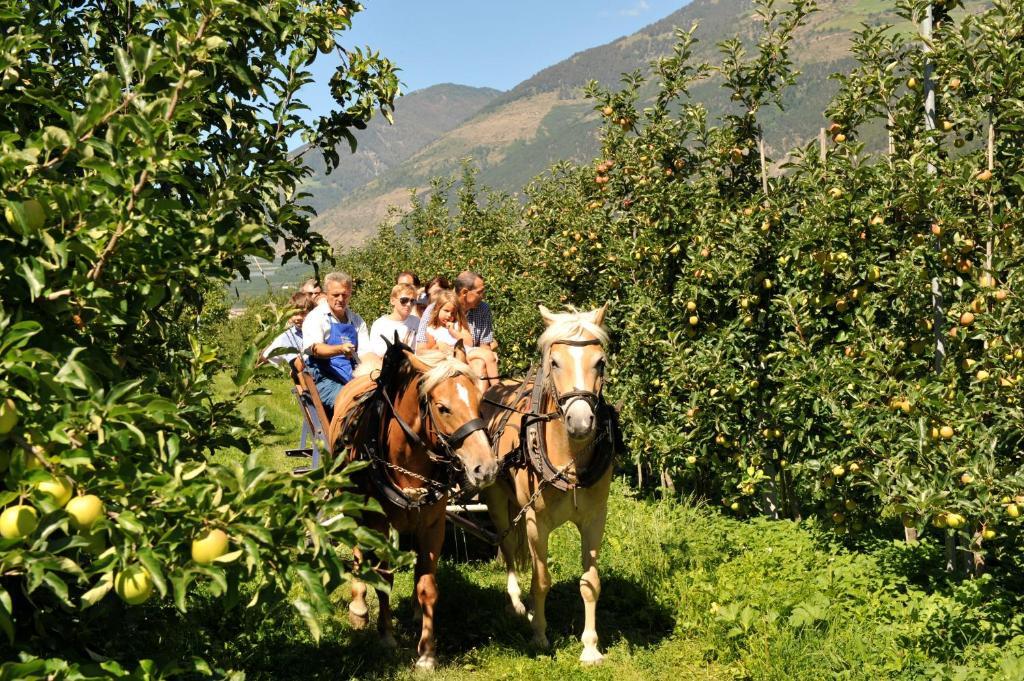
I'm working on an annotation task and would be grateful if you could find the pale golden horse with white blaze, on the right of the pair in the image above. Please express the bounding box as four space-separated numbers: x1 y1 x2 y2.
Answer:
481 305 621 665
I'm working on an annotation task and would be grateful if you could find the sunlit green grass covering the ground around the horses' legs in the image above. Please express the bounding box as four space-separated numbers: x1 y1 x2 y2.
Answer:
167 378 1024 681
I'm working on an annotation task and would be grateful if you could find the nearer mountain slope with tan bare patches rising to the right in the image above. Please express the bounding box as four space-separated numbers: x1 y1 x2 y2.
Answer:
313 0 986 246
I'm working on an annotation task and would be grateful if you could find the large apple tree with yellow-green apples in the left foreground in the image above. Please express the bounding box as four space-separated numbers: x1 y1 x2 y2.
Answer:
0 0 400 678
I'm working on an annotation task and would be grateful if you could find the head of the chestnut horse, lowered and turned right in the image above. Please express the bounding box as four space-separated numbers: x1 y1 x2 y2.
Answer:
406 350 498 491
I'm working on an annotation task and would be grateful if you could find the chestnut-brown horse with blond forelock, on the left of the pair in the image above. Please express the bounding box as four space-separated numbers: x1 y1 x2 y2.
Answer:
330 338 498 670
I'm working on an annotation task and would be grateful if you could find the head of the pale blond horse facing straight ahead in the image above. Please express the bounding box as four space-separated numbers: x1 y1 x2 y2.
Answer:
538 304 608 440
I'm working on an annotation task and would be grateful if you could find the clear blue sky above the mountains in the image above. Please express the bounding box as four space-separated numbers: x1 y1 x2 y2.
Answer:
302 0 689 116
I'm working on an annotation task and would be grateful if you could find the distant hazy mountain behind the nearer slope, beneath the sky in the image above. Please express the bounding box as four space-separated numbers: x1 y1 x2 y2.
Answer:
295 83 501 218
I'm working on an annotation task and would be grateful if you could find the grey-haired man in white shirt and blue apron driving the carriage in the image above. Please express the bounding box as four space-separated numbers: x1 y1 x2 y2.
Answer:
302 272 370 416
